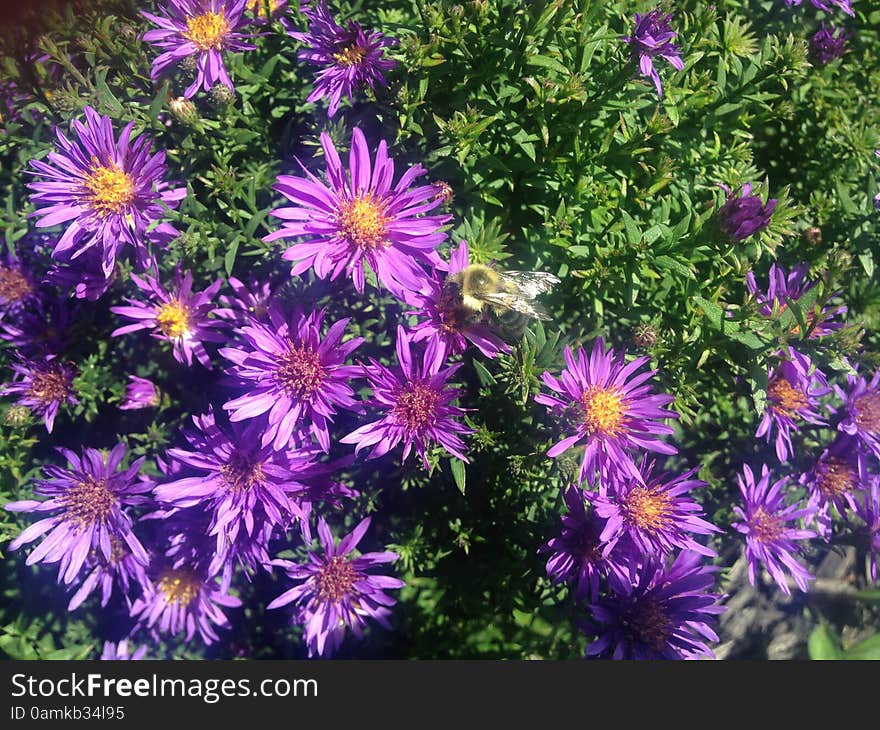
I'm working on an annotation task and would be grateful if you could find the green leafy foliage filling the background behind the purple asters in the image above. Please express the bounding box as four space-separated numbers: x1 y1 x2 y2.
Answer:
0 0 880 658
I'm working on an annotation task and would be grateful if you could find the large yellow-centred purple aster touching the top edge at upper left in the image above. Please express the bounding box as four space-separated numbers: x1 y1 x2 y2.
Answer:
142 0 256 99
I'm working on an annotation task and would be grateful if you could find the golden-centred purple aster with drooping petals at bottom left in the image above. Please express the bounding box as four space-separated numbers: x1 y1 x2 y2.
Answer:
130 565 241 644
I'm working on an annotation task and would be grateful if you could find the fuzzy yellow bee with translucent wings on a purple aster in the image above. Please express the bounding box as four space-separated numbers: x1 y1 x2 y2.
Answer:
441 264 559 341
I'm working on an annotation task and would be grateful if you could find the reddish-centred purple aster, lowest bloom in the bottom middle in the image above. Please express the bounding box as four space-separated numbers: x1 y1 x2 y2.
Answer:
268 517 405 656
